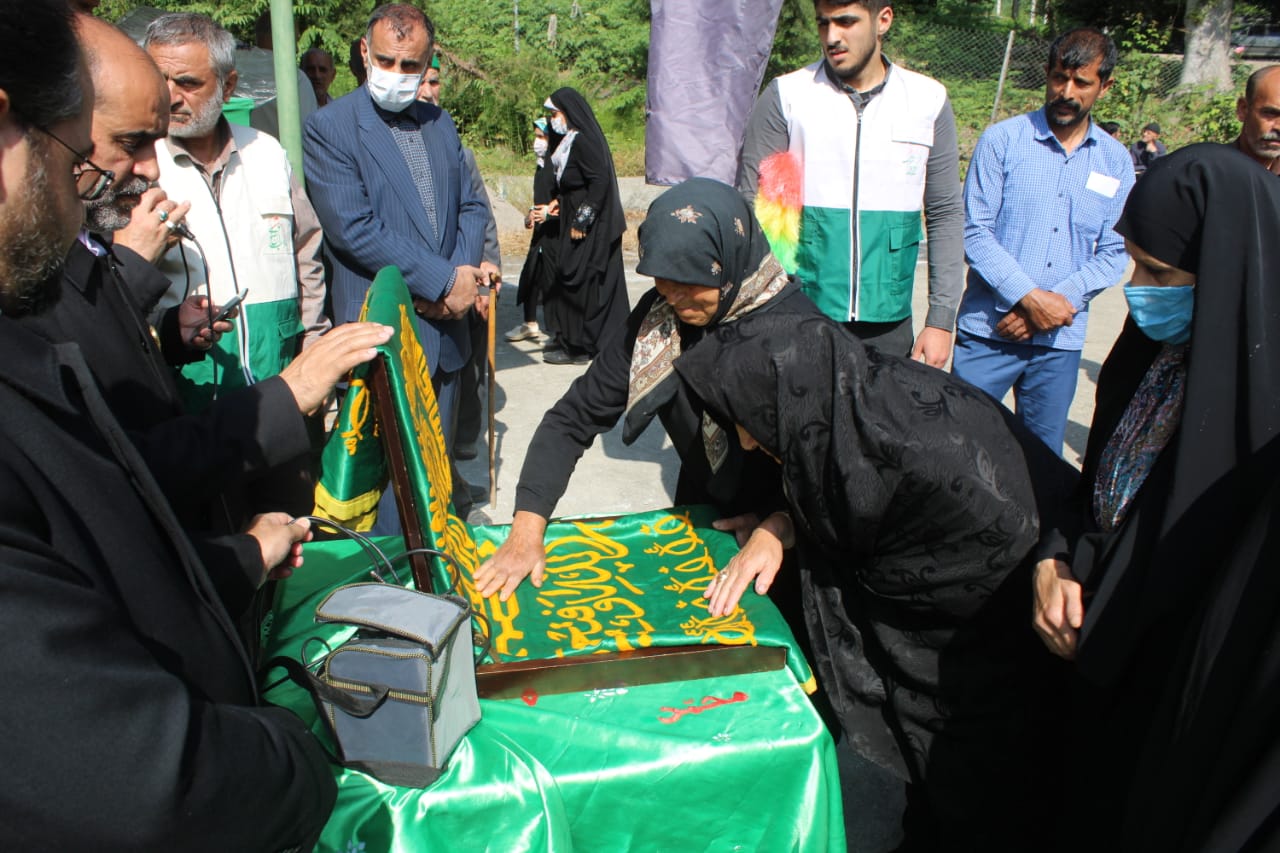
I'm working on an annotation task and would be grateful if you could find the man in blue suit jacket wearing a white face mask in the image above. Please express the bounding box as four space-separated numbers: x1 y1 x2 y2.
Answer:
303 4 489 446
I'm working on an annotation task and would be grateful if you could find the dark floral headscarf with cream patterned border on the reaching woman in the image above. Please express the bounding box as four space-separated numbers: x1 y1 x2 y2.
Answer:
623 178 788 445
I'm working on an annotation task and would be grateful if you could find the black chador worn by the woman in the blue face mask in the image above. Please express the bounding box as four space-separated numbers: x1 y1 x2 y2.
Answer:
1073 145 1280 850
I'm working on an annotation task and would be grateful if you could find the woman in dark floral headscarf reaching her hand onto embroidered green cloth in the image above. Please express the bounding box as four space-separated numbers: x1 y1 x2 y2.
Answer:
476 178 818 598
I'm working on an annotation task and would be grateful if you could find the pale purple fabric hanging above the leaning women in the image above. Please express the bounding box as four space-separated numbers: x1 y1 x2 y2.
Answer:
644 0 782 184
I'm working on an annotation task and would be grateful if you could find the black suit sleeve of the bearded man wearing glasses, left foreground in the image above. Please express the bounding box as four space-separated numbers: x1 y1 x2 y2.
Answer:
0 470 335 852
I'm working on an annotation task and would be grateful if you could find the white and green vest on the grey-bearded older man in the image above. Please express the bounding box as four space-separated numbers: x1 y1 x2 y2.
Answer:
156 124 303 411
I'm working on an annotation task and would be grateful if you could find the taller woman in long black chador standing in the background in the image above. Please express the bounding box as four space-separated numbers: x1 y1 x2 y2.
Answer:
543 87 627 364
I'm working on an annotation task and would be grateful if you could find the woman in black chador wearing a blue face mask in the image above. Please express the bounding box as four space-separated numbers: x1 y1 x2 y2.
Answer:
1036 145 1280 853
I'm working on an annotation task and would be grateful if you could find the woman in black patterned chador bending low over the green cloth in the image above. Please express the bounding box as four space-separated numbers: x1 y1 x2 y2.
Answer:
676 306 1074 853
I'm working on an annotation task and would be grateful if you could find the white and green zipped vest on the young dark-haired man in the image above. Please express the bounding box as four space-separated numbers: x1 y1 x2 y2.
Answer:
778 61 947 323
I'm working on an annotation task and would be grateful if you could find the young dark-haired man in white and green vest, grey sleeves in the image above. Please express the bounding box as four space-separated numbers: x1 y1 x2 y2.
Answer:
737 0 964 368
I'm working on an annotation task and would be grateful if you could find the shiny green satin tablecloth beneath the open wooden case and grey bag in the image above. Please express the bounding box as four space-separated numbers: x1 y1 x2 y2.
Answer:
266 527 845 853
